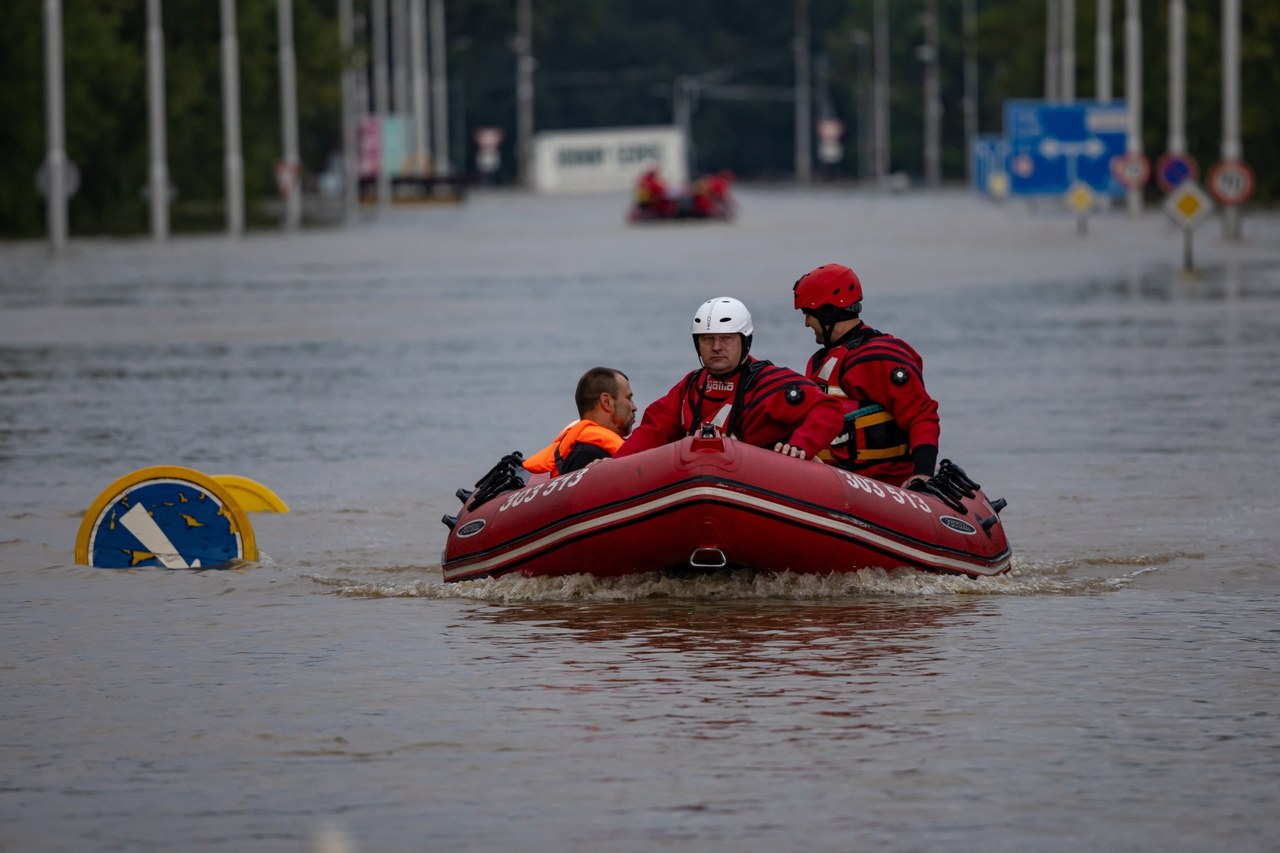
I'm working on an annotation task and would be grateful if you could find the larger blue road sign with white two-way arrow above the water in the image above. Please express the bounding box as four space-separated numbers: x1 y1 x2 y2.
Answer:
1005 100 1129 197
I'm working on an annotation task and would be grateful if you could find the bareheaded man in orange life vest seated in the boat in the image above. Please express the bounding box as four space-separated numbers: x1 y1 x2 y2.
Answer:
524 368 636 476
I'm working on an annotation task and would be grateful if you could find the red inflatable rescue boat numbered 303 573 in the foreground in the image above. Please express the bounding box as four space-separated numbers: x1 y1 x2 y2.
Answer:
440 435 1010 581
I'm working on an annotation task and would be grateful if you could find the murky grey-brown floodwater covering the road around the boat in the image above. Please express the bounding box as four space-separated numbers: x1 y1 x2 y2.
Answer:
0 188 1280 853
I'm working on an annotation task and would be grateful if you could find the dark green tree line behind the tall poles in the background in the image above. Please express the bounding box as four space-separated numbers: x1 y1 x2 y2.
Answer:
0 0 1280 237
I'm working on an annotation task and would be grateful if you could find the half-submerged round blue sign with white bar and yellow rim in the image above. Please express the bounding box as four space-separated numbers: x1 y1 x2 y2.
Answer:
76 465 258 569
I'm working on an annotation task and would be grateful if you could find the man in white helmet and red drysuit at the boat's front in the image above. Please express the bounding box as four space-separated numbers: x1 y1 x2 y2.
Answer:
613 296 844 459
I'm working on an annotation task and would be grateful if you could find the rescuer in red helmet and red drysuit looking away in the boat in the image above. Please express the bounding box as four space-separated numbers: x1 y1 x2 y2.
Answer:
792 258 941 485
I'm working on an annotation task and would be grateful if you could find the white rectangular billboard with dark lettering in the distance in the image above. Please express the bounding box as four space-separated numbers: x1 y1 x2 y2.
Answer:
534 126 689 192
